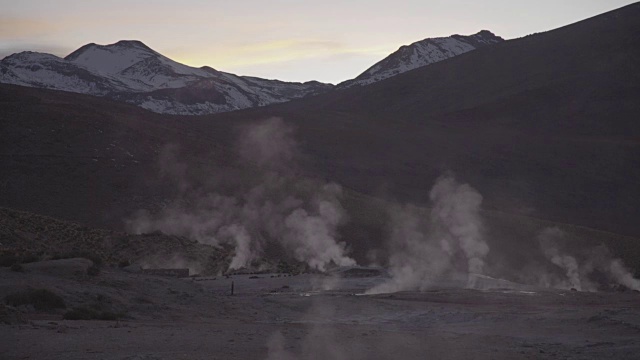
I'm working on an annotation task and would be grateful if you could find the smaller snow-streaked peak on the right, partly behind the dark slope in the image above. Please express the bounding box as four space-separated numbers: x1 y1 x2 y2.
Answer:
337 30 504 89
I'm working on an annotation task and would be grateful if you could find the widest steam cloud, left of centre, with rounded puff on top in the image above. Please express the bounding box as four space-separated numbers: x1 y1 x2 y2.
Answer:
128 118 355 270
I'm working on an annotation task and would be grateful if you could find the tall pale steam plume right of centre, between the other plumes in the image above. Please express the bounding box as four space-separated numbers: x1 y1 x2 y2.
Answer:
367 176 489 294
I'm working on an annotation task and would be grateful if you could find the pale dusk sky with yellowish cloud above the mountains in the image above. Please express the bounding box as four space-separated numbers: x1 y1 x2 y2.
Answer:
0 0 634 83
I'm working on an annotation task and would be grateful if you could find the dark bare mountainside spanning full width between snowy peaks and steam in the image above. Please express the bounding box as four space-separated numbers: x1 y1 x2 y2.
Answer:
0 4 640 268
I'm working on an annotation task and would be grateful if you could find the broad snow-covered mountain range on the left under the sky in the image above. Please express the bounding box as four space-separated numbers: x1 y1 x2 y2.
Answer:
0 41 333 115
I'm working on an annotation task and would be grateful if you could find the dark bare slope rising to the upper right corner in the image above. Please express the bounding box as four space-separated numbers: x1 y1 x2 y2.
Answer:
204 4 640 236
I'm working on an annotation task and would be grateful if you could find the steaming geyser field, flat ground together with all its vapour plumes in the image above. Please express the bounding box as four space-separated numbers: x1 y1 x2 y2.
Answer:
0 119 640 360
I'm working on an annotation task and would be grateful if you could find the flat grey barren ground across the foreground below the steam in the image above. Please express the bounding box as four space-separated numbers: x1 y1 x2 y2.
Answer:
0 259 640 359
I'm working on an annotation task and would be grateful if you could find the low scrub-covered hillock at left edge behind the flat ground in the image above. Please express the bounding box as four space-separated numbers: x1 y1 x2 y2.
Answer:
0 208 229 275
